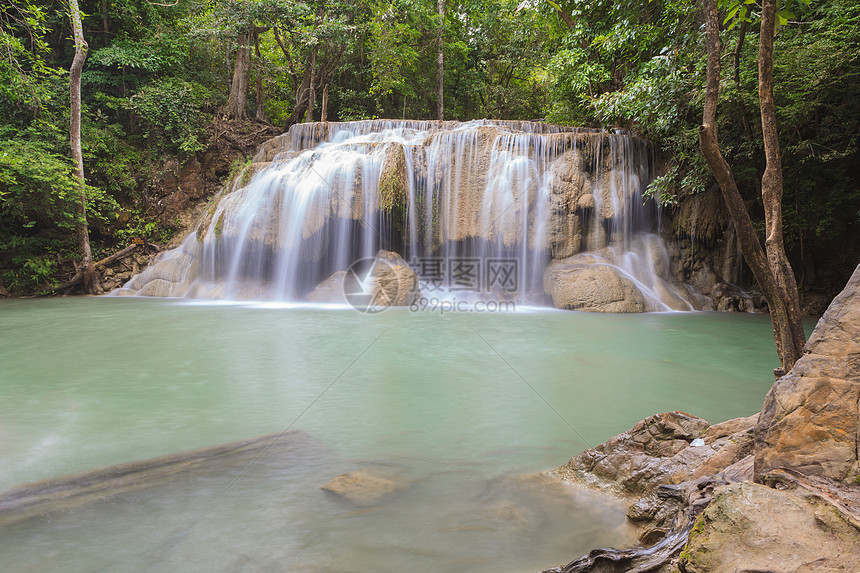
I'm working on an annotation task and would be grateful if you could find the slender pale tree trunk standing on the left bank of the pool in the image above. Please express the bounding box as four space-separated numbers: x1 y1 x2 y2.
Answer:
69 0 101 294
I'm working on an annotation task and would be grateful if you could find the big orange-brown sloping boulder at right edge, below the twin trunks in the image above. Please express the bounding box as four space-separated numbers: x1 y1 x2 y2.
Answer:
755 267 860 482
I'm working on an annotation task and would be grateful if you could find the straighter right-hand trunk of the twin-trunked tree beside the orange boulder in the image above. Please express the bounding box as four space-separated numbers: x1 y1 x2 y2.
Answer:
758 0 806 372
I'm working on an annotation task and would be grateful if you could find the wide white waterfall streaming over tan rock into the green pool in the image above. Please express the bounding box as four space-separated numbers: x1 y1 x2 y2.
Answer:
114 120 704 312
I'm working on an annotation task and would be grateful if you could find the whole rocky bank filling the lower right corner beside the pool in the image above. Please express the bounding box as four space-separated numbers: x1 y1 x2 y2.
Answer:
545 266 860 573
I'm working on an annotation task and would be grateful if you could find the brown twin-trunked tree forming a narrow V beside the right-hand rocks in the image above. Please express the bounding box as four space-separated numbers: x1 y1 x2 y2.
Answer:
699 0 805 375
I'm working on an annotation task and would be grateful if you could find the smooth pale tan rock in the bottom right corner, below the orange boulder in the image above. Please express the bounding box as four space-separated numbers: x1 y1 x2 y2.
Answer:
680 483 860 573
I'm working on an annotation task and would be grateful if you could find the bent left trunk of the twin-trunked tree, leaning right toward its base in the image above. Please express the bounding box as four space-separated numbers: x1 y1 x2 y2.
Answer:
699 0 803 374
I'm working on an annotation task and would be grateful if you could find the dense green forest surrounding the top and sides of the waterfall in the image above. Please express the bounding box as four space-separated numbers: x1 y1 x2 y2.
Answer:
0 0 860 293
